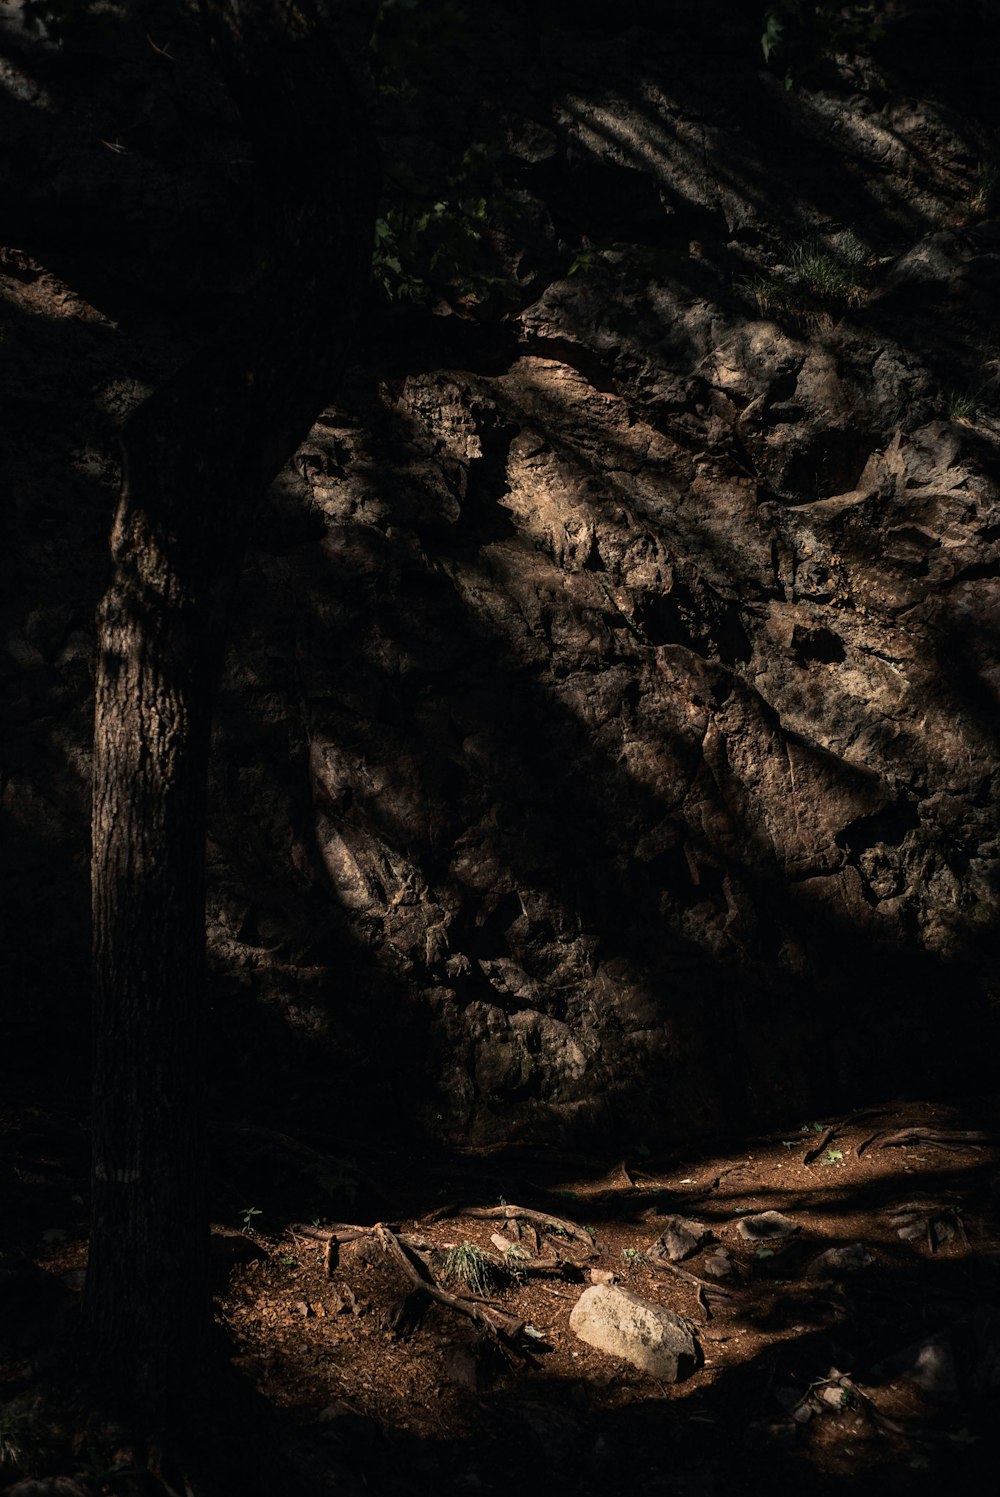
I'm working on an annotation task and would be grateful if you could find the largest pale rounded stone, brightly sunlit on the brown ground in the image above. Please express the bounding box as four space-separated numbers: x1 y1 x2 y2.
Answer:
569 1284 698 1383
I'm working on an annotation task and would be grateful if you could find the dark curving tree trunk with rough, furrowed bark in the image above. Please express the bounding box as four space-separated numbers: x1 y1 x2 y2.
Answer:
84 0 377 1416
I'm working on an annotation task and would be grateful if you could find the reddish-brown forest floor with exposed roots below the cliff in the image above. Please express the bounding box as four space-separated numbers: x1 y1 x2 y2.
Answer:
0 1102 1000 1497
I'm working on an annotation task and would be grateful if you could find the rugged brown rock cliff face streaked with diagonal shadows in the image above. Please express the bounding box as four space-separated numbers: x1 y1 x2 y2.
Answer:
9 3 1000 1139
